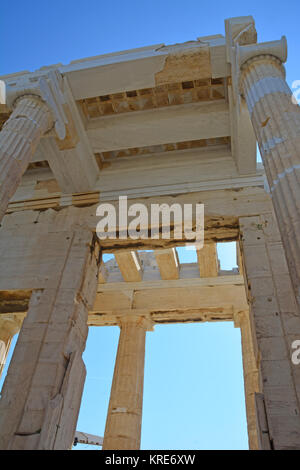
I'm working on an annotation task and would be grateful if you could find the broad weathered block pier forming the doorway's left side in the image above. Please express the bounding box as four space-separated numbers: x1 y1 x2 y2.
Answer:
0 230 100 450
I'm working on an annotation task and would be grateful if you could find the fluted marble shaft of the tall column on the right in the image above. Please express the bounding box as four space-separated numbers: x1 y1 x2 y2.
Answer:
240 55 300 307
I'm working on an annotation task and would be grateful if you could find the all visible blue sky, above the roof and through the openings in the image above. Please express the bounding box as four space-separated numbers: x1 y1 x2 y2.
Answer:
0 0 300 449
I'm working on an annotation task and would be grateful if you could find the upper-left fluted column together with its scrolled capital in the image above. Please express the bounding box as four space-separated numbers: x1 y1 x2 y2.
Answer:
0 71 68 221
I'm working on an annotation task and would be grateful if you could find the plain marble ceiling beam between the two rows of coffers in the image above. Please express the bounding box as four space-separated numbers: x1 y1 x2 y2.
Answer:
87 100 230 152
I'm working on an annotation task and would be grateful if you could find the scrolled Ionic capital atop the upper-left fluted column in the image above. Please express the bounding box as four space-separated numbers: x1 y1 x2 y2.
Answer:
2 70 68 140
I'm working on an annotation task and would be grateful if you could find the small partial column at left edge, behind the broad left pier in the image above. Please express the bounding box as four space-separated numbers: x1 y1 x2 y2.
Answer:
0 314 23 377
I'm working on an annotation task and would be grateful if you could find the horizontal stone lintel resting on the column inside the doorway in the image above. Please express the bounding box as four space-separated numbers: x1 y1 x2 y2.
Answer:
90 275 248 325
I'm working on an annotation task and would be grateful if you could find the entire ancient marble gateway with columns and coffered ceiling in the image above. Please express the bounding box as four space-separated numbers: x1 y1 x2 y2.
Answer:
0 17 300 449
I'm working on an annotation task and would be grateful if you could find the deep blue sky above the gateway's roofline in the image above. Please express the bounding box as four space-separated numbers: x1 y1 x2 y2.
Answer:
0 0 300 87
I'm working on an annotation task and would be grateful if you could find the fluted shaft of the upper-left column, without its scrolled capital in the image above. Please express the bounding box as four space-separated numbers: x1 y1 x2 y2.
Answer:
0 95 53 221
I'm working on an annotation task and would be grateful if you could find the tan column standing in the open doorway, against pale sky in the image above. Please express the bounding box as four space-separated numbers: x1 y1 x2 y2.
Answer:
102 315 151 450
